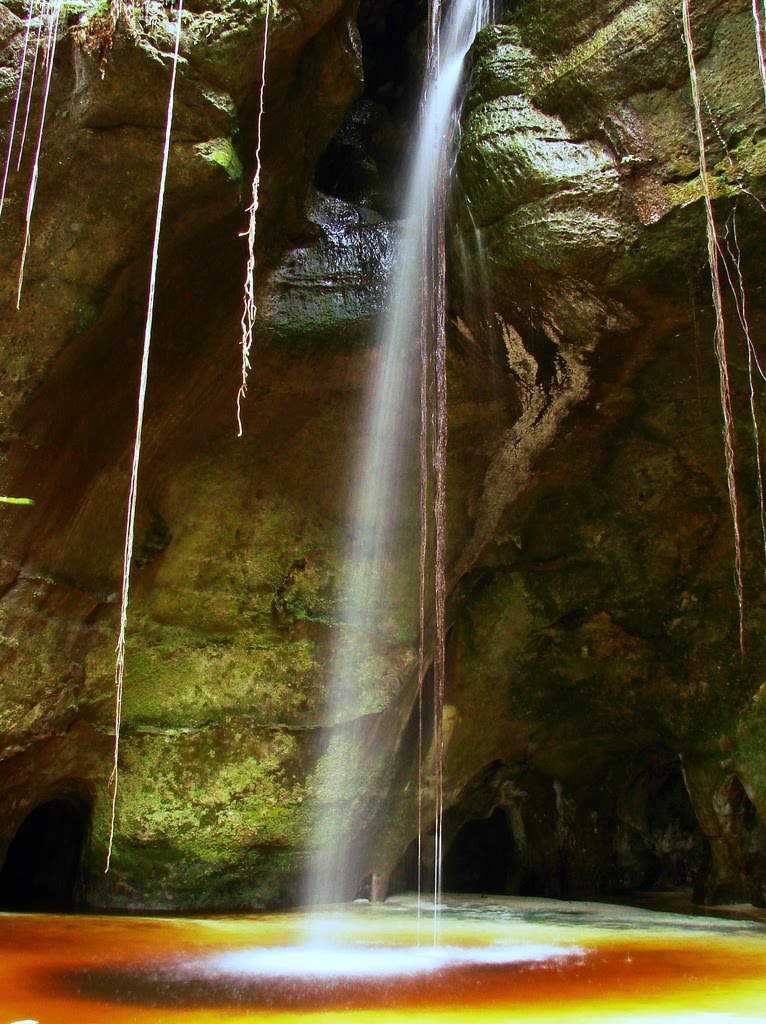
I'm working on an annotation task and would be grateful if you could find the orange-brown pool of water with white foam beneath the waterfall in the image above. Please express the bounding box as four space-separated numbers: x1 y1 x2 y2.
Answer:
0 897 766 1024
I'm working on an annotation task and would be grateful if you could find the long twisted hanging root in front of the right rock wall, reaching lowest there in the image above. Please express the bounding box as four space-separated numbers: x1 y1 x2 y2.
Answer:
681 0 744 654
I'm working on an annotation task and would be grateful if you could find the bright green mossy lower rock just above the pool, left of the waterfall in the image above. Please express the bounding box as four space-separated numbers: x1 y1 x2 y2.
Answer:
94 728 307 906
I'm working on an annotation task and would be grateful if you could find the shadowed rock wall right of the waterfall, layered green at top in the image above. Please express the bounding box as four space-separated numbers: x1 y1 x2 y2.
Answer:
407 3 764 905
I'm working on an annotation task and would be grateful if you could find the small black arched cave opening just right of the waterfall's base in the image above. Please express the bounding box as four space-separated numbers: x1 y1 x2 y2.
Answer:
442 807 515 896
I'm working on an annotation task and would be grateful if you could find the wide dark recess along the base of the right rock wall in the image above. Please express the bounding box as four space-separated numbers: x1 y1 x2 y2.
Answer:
390 749 716 900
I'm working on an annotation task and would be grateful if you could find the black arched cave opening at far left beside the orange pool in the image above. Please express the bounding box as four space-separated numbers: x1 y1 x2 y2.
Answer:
0 797 90 911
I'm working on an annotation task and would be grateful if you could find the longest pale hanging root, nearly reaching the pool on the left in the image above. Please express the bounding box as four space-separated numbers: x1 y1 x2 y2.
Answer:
104 0 183 874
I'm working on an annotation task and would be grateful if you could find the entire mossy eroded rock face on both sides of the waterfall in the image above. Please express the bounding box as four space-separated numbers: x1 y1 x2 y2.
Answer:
0 0 766 907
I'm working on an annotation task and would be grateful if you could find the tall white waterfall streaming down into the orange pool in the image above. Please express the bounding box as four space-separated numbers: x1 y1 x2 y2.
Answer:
306 0 492 904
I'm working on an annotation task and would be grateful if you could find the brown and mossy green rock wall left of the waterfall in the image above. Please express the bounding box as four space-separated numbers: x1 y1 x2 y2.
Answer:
0 2 370 906
